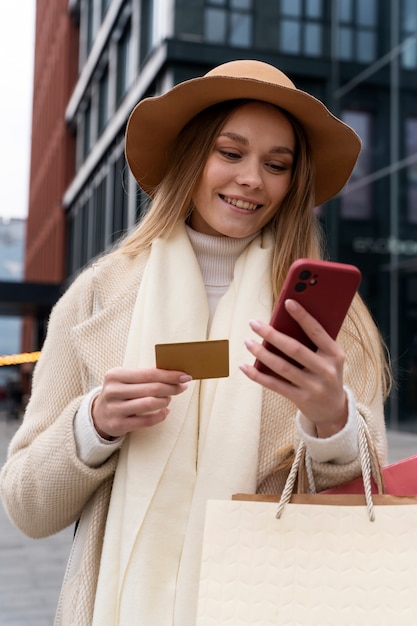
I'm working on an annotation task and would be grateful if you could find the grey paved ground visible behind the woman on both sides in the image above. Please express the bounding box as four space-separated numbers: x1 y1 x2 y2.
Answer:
0 413 417 626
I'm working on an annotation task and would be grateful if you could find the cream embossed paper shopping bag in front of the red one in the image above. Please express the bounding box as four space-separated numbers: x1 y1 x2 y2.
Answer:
196 496 417 626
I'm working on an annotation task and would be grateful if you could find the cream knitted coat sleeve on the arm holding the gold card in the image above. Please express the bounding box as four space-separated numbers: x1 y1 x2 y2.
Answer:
0 270 117 537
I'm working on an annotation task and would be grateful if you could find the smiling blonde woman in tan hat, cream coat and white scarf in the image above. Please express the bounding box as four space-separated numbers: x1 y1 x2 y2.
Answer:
1 61 386 626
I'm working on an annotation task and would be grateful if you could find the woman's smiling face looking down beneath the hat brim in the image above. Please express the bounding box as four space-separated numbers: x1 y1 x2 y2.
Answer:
190 102 296 238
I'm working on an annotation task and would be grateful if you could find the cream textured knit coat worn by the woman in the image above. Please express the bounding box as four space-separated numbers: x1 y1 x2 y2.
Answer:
0 246 386 626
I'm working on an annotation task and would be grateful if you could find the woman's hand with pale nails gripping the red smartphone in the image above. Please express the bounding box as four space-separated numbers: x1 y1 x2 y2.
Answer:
241 300 348 437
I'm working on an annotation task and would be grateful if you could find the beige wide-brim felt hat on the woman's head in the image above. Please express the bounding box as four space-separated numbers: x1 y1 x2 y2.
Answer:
126 60 361 205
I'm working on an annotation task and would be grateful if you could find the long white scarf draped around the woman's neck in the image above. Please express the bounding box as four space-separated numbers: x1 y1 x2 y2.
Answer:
93 224 272 626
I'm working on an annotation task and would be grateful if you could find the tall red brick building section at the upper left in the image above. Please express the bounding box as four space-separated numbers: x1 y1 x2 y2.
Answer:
22 0 78 351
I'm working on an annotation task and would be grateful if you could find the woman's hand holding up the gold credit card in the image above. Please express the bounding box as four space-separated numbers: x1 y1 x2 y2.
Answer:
91 367 192 440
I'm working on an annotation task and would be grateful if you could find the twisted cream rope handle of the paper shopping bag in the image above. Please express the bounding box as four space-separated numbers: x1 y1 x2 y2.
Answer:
275 411 385 522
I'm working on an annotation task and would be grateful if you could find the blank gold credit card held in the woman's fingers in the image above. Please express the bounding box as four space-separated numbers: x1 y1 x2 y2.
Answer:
155 339 229 379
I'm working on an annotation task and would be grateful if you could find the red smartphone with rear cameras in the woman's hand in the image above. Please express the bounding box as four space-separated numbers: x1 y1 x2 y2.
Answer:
255 259 361 376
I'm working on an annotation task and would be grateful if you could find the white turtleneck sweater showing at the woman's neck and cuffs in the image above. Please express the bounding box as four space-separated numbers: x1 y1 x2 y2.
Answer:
74 226 358 467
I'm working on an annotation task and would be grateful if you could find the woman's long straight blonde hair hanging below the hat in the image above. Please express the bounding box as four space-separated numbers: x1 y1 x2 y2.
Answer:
113 100 391 397
